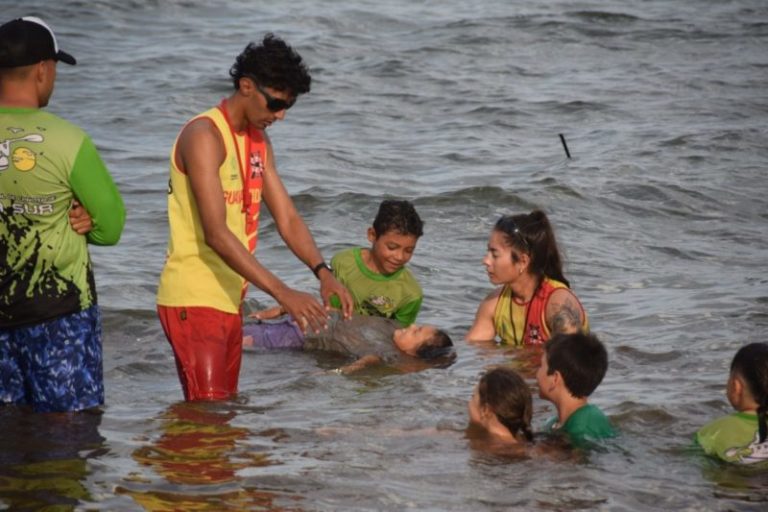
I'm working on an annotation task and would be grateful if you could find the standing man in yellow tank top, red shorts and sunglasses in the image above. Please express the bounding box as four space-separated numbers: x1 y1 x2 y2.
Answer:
157 34 353 400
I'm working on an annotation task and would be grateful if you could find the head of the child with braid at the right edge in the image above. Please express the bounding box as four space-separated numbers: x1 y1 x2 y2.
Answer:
726 343 768 443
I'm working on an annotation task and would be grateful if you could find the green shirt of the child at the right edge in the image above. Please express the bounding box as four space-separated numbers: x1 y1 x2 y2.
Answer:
695 412 768 466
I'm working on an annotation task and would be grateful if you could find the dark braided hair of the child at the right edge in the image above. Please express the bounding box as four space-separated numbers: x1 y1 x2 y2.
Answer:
731 343 768 443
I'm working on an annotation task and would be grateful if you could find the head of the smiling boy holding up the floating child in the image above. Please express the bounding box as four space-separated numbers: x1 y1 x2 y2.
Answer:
368 199 424 275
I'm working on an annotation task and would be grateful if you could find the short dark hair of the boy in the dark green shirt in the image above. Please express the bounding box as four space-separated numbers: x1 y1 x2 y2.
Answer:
544 332 608 398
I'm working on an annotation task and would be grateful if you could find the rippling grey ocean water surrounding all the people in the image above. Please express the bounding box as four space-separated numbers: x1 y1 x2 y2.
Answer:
0 0 768 511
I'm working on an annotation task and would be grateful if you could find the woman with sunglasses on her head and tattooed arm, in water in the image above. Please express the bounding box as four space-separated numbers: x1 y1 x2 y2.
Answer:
467 210 589 346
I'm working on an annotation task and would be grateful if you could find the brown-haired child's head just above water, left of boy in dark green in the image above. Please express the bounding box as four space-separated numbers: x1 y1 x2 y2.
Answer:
468 367 533 444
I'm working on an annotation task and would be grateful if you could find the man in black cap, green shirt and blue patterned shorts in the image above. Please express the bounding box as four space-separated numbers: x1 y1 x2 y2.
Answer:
0 17 125 412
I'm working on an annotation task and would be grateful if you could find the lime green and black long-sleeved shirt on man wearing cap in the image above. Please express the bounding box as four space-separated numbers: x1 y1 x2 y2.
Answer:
0 107 125 327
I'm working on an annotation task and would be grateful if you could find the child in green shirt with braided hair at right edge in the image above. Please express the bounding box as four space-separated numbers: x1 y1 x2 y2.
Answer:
696 343 768 466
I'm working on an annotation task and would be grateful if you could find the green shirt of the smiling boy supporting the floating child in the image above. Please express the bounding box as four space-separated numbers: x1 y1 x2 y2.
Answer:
331 247 423 327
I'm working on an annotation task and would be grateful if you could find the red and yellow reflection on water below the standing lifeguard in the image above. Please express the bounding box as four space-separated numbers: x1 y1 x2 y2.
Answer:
116 402 301 511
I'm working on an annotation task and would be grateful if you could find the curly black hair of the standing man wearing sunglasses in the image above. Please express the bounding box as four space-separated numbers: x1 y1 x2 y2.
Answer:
229 34 312 97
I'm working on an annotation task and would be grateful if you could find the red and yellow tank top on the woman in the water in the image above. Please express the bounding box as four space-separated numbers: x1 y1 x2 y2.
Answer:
493 277 589 345
